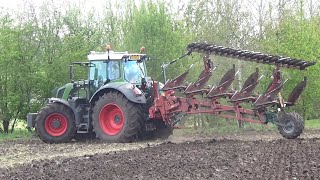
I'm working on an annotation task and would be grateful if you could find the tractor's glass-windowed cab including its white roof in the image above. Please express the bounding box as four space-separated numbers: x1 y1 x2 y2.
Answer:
88 51 147 89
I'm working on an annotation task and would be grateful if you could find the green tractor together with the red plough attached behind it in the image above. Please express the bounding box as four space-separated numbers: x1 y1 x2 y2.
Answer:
27 43 315 143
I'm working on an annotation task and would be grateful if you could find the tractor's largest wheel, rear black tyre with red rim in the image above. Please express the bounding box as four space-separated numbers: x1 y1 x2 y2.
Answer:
92 92 144 142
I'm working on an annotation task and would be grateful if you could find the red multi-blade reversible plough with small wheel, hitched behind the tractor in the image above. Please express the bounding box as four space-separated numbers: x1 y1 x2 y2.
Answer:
149 43 315 139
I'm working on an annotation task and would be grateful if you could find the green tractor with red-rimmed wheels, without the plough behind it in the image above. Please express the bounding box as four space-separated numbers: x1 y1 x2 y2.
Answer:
27 48 168 143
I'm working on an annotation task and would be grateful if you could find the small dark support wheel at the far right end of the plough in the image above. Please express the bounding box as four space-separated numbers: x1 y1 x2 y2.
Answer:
278 112 304 139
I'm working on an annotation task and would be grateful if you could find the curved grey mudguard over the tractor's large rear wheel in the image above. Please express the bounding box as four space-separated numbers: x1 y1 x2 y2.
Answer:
90 82 146 104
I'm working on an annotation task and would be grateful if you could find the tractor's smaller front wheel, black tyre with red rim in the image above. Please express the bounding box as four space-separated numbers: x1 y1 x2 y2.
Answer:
35 103 76 143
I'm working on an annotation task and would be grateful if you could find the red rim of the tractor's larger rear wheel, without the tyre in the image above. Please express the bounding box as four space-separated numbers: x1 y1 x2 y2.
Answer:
99 104 124 136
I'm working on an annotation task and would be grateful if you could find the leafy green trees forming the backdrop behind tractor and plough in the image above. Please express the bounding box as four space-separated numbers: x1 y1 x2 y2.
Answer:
0 0 320 133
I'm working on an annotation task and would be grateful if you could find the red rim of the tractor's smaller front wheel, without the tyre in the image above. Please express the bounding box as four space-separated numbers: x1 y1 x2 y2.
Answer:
44 113 68 136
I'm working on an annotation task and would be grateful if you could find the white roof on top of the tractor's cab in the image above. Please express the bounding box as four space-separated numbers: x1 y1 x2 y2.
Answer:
88 51 145 61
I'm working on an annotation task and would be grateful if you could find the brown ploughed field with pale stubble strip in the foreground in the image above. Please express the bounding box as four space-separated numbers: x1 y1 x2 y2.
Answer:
0 131 320 179
